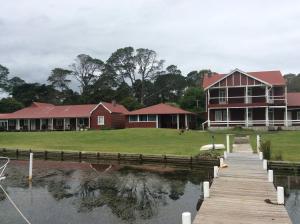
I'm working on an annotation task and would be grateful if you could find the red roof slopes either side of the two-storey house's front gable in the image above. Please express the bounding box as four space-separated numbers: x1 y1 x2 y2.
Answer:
203 71 285 89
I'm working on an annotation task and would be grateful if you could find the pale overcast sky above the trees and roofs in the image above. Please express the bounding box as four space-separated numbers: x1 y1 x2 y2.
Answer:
0 0 300 82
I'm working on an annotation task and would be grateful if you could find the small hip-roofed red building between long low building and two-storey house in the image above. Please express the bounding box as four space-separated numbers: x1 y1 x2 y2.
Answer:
126 103 195 129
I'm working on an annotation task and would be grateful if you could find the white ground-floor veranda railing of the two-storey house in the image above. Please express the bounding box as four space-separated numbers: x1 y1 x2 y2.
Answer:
202 120 300 129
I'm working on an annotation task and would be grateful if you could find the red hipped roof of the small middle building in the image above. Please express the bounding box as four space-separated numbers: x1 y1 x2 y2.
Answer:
127 103 192 115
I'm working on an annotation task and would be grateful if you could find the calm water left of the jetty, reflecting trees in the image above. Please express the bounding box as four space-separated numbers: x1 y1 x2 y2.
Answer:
0 161 211 224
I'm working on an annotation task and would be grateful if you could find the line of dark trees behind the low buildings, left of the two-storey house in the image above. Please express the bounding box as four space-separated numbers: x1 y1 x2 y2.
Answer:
0 47 206 113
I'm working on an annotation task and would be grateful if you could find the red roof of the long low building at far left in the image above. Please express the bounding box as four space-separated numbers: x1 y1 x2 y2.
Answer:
0 102 128 119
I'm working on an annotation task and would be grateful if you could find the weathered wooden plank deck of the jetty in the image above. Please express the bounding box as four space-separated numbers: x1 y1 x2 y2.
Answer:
193 144 291 224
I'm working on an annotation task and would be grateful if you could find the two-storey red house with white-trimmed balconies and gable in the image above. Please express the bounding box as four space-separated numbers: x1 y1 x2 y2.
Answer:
203 69 300 127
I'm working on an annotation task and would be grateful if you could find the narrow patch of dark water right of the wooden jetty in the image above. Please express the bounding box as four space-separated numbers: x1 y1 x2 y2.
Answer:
274 170 300 224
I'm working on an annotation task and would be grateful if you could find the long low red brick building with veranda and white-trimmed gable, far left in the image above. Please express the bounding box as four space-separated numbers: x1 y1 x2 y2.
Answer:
0 102 128 131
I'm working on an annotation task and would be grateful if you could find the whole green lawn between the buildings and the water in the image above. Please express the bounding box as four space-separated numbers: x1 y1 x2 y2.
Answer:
0 129 300 161
